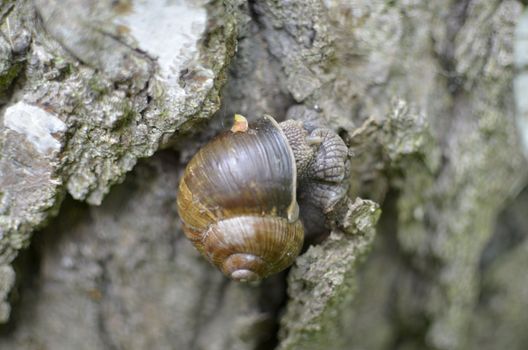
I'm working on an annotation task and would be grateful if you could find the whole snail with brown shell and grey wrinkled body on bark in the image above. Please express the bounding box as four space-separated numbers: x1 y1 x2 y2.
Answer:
177 115 348 281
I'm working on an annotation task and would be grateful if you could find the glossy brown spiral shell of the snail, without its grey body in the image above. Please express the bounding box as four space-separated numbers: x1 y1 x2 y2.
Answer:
178 116 304 281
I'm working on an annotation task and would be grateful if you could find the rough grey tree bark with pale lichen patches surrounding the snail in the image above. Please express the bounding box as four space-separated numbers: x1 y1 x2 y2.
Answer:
0 0 528 350
